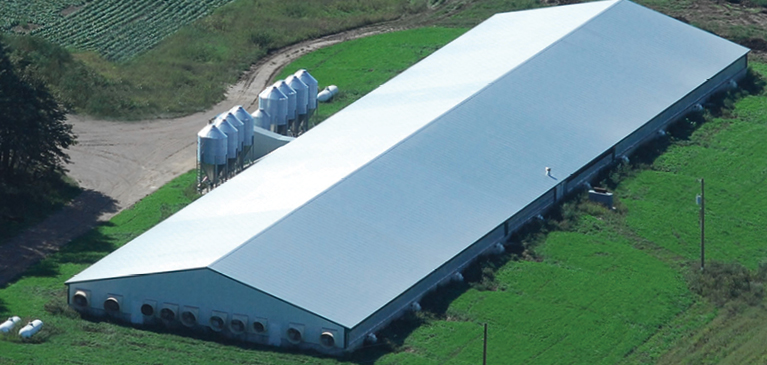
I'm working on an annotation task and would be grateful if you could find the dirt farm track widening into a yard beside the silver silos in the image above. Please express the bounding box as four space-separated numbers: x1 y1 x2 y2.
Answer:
0 21 412 287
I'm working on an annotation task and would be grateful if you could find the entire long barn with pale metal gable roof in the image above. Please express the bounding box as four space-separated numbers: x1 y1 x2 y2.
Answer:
67 0 748 353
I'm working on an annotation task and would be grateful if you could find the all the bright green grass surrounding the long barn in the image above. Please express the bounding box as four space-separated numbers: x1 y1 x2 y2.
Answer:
0 28 767 364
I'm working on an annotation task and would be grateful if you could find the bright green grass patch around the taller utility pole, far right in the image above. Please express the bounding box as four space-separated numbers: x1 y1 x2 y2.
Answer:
619 69 767 269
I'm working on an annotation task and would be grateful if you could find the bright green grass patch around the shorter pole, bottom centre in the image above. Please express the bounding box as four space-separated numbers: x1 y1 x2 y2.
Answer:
382 218 693 364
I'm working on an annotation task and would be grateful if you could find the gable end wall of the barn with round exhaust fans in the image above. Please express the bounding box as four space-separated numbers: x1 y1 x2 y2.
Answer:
69 269 345 353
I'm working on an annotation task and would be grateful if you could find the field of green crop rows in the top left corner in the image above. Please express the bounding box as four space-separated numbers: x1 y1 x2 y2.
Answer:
0 0 232 61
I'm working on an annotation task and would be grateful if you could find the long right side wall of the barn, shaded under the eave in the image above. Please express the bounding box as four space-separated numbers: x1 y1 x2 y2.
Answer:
347 56 748 350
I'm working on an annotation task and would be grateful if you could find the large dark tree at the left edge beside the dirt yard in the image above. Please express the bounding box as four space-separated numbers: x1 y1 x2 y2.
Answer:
0 39 76 182
